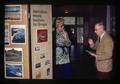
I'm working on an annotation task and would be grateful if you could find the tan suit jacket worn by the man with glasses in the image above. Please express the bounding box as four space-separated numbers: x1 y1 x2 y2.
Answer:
91 32 114 72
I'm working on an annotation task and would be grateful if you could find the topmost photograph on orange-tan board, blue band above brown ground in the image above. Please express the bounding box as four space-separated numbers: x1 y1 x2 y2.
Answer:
5 5 22 21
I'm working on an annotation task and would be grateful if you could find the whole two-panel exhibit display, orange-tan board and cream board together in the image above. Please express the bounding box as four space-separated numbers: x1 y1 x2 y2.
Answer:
4 4 53 79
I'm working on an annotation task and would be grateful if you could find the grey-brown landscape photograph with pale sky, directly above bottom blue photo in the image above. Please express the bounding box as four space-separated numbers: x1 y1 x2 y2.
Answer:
4 48 23 62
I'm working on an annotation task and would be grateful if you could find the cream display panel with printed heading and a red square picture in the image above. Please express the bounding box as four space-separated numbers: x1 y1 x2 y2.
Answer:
30 5 53 79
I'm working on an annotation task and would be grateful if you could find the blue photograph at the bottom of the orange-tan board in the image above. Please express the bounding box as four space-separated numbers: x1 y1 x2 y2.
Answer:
5 64 23 78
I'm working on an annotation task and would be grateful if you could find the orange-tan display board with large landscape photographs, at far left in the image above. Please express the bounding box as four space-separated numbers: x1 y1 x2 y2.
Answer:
4 4 30 79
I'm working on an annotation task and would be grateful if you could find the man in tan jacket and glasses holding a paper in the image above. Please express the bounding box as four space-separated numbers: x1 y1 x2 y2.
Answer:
88 22 113 79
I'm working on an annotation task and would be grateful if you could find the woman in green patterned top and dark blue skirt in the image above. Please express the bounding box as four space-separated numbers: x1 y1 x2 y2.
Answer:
55 17 71 79
